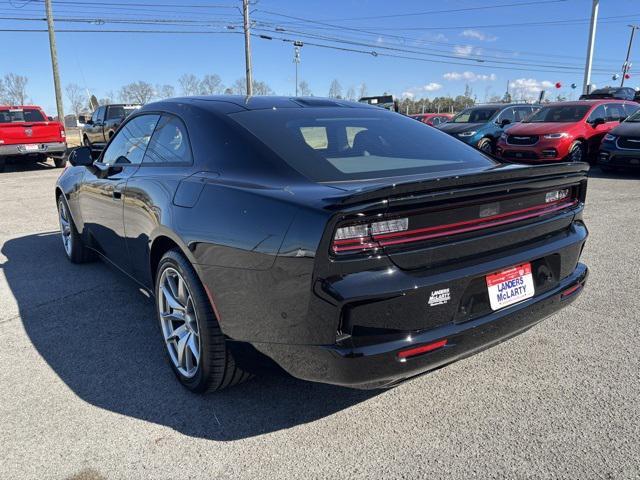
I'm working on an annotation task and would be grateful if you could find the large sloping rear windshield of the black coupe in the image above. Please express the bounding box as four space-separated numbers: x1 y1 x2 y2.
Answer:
230 108 495 182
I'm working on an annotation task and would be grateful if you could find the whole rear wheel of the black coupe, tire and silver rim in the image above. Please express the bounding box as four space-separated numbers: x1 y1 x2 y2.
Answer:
155 249 250 392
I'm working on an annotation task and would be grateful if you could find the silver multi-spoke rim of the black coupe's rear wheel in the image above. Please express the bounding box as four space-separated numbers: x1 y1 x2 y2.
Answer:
158 267 200 378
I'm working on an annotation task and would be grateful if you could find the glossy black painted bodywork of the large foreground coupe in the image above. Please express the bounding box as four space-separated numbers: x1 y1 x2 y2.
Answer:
57 97 587 387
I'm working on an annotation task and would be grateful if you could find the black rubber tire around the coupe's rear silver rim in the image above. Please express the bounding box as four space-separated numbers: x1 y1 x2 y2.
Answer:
155 249 251 393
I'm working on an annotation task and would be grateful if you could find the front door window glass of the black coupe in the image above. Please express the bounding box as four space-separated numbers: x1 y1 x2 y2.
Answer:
101 115 160 165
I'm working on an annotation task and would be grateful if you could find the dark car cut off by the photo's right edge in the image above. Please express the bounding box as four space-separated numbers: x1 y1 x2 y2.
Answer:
598 121 640 170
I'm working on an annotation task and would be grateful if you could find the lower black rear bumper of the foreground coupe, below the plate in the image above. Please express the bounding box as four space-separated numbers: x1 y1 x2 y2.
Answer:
254 263 588 388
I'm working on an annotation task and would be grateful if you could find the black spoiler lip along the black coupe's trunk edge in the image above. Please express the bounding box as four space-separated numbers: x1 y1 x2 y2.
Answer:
337 162 589 205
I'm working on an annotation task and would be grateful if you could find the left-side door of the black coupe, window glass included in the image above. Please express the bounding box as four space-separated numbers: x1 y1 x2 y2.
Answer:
78 110 160 273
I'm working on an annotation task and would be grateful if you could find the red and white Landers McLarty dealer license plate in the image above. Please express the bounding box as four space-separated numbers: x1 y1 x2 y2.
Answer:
487 263 534 310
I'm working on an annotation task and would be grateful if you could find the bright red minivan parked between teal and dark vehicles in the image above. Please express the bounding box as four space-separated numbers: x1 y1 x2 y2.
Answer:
496 100 640 162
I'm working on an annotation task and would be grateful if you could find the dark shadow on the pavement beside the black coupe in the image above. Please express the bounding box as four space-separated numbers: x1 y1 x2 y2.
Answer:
0 232 379 441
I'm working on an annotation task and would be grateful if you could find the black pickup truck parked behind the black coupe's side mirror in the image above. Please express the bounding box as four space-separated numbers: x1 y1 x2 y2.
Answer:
78 103 141 150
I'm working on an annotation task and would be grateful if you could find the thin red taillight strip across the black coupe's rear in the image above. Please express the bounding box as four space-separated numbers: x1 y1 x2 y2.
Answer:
332 200 578 253
